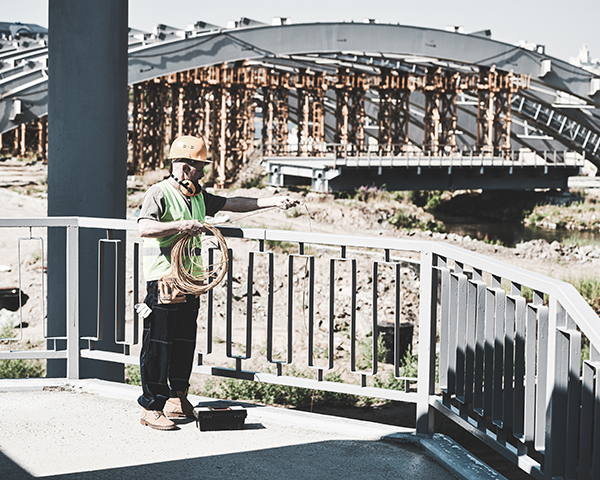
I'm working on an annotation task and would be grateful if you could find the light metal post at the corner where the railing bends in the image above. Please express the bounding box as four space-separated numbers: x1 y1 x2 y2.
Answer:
417 250 437 434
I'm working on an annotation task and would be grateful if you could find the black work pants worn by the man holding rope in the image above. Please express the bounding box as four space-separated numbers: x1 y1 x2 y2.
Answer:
138 281 198 410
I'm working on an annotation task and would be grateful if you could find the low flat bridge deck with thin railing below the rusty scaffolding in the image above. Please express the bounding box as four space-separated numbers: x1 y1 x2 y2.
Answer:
263 154 584 192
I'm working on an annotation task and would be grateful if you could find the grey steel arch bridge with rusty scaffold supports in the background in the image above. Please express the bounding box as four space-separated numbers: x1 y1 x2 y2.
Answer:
0 19 600 190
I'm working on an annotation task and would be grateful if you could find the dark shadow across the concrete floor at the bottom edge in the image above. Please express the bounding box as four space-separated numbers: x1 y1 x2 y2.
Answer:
0 437 455 480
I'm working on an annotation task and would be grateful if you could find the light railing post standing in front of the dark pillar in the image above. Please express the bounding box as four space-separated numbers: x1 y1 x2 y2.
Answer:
66 225 79 379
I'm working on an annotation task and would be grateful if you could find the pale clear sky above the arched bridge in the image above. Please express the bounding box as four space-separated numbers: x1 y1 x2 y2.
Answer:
0 0 600 61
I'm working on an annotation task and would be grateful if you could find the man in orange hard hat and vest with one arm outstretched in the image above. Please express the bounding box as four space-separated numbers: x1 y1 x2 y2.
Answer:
136 136 298 430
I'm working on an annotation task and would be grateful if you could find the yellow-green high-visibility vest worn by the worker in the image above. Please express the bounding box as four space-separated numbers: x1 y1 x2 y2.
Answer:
143 180 206 282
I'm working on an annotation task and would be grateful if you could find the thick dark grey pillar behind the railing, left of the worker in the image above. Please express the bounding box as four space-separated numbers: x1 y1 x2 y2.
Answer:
48 0 128 381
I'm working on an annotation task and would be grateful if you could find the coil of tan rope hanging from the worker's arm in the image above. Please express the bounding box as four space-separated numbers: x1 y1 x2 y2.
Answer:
171 223 229 296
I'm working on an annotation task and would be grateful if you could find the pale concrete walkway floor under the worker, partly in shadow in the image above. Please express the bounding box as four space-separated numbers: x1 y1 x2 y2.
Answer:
0 379 504 480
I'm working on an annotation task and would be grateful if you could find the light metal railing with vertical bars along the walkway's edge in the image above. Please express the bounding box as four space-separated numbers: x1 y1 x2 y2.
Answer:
0 217 600 478
